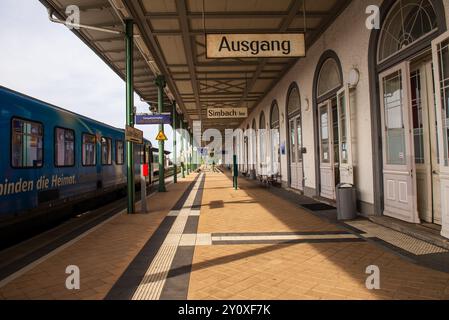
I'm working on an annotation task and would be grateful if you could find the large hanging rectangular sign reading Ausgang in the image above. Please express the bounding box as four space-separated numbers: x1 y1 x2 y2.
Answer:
206 33 306 59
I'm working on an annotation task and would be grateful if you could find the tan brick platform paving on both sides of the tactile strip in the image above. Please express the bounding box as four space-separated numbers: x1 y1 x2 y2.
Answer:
5 173 449 300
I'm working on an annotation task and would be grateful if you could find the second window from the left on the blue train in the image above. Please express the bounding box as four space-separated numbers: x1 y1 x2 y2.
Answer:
55 128 75 167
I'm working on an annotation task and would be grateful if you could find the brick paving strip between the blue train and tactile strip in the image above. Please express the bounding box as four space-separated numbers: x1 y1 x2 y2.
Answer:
0 175 195 300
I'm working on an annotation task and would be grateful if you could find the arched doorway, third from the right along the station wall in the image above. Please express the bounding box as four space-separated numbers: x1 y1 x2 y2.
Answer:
286 83 304 191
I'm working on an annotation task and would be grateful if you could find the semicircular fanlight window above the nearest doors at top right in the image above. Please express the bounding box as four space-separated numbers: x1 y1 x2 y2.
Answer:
378 0 438 62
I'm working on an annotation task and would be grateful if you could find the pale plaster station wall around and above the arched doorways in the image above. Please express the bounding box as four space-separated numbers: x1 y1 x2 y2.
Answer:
242 0 382 214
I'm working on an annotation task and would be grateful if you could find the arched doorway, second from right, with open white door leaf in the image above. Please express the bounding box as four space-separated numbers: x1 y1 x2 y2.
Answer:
313 50 349 200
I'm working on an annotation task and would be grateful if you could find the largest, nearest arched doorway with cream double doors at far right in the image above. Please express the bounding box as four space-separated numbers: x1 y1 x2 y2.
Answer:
369 0 449 225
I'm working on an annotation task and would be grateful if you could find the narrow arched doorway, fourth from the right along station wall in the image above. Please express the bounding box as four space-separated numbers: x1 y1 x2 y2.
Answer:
270 101 282 183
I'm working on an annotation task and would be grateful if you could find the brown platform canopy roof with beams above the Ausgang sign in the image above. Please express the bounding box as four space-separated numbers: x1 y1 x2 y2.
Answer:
41 0 350 130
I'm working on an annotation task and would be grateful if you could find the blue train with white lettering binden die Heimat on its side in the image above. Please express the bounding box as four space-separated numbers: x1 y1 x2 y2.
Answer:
0 86 168 242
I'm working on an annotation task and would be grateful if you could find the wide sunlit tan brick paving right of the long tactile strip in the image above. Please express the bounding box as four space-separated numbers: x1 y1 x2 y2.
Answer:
189 174 449 299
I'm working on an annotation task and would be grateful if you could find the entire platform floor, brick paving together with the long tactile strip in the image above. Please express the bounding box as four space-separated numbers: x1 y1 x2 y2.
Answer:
0 172 449 300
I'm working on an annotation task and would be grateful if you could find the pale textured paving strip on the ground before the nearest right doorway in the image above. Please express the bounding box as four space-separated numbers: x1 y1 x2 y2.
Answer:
346 221 448 256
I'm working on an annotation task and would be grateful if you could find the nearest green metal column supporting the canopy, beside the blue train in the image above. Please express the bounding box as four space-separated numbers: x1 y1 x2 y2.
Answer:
125 20 136 214
